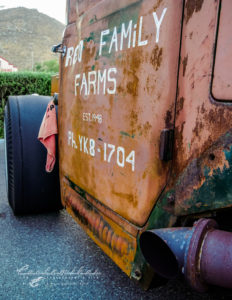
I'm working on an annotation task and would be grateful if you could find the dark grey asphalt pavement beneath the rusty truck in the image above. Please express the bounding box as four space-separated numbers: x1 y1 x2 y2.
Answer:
0 140 232 300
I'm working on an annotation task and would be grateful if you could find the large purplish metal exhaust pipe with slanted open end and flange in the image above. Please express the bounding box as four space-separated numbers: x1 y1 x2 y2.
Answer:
140 219 232 292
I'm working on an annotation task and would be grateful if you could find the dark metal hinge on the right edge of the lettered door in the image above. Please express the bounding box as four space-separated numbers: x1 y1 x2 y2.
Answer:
160 129 174 161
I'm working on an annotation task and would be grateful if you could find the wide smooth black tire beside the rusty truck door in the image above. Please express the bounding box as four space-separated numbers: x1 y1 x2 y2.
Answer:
4 95 62 215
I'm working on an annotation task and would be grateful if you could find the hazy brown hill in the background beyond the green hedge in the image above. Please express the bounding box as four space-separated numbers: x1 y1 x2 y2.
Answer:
0 7 64 70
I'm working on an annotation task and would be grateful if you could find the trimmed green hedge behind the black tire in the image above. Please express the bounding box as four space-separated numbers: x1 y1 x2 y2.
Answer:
0 72 51 138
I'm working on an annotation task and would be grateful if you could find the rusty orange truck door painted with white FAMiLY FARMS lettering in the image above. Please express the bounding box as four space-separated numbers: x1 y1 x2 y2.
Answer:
59 0 183 226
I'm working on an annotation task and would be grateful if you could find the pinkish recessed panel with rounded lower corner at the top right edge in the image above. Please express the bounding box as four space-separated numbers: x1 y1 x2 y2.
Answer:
212 0 232 101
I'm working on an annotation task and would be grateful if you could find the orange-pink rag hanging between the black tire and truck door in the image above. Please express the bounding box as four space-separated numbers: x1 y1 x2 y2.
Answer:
38 100 58 172
